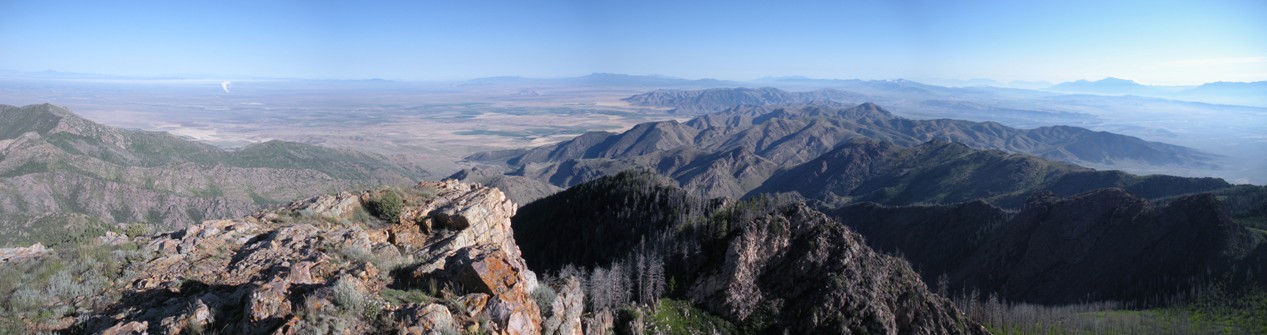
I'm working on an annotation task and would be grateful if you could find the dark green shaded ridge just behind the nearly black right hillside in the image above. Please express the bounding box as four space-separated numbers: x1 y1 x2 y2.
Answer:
746 138 1232 208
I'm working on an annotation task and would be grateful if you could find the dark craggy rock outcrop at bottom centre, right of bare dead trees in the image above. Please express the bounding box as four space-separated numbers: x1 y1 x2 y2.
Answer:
687 204 986 334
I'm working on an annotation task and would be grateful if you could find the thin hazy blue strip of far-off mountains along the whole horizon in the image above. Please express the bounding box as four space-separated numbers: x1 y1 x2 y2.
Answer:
7 70 1267 108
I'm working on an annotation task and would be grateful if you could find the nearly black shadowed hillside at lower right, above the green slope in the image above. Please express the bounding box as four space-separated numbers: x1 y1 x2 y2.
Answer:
830 189 1267 305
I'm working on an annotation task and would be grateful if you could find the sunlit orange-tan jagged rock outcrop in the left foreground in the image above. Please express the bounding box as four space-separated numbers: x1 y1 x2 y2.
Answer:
77 181 552 334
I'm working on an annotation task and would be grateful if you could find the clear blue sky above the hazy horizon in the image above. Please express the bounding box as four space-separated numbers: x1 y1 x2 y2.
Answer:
0 0 1267 85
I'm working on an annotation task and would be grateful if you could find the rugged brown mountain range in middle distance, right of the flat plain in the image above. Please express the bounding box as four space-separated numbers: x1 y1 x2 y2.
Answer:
454 103 1213 200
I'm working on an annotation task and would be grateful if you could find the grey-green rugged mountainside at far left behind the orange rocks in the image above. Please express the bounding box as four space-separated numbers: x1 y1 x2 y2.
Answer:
0 104 426 245
